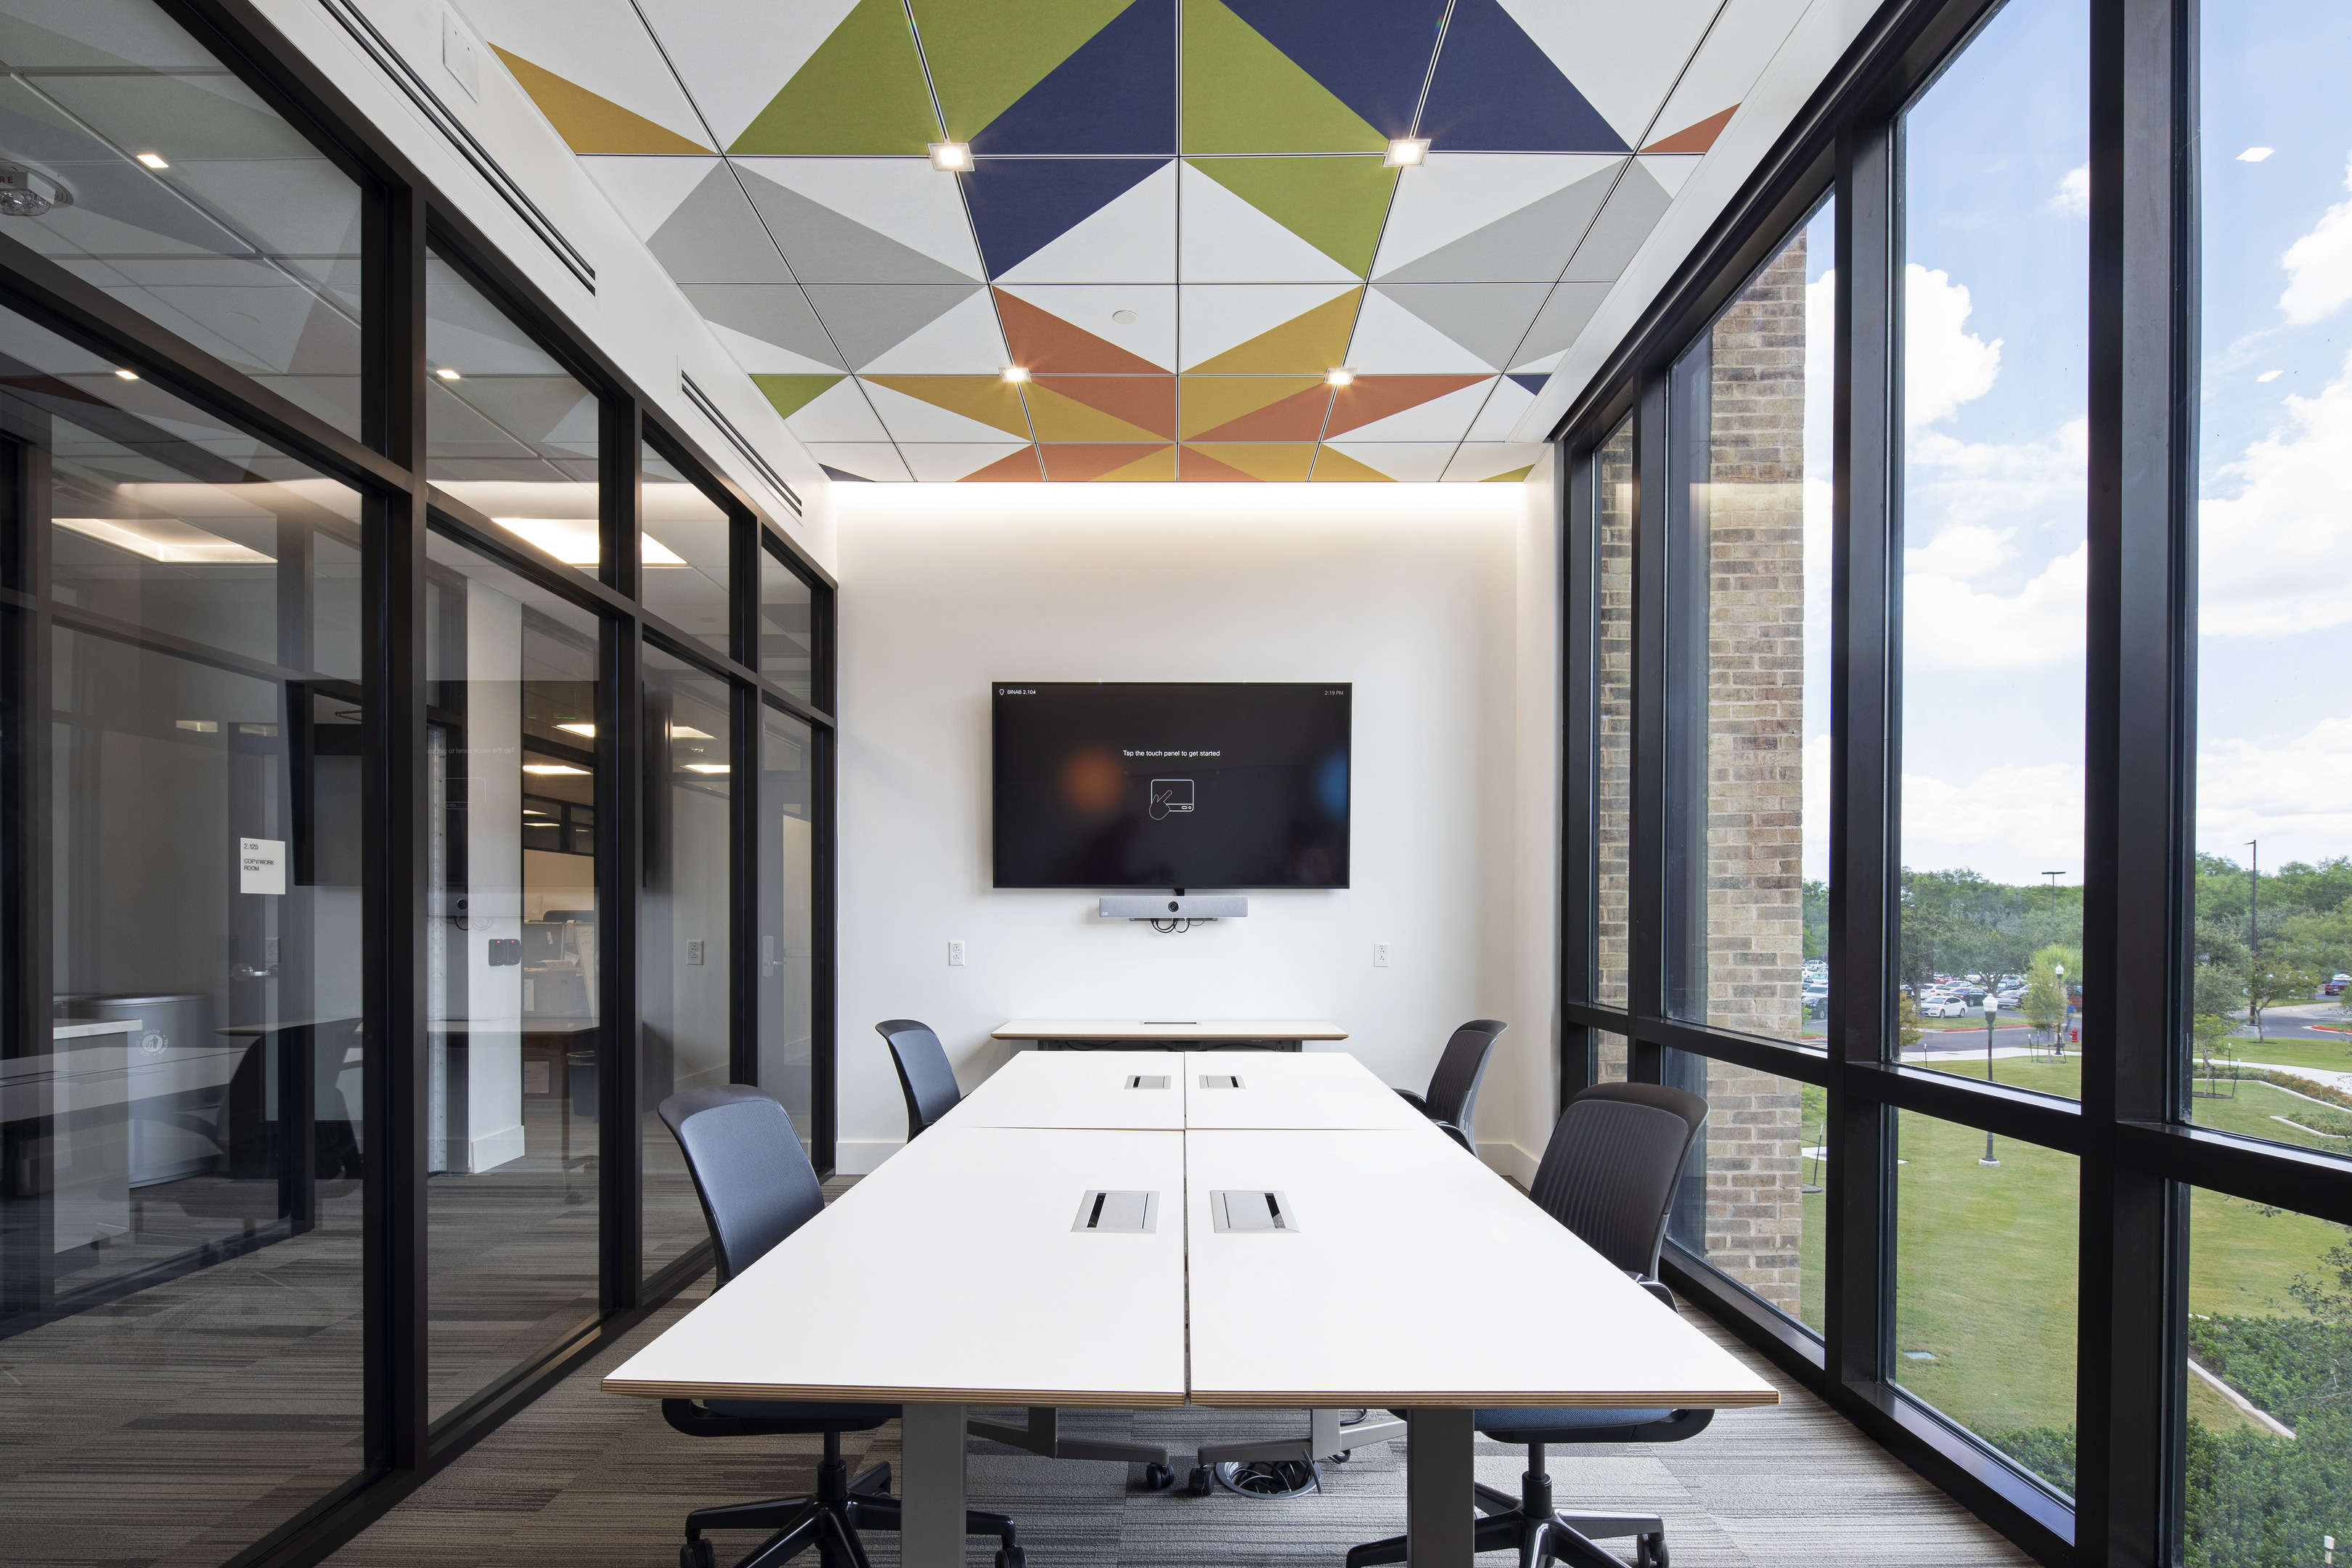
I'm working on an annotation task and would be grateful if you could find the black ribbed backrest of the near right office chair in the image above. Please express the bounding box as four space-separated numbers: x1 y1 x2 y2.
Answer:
1529 1084 1707 1279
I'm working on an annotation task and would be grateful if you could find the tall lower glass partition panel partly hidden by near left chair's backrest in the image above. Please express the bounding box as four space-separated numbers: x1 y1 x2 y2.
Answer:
637 647 734 1274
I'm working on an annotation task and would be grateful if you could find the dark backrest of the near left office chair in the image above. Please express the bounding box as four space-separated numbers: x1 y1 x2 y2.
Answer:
661 1084 825 1286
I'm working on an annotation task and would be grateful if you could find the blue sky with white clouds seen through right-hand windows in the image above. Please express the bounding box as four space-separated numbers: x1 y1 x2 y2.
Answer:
1806 0 2352 884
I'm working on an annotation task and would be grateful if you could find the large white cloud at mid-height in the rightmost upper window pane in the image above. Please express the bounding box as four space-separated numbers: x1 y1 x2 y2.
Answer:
2197 346 2352 637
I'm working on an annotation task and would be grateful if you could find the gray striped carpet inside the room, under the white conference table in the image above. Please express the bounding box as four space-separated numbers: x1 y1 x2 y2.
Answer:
332 1259 2028 1568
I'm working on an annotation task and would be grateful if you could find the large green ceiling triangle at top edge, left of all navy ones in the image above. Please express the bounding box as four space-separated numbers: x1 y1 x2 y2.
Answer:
727 0 939 158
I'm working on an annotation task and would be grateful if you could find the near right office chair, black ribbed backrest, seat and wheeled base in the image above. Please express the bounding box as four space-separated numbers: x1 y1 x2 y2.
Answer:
1348 1084 1715 1568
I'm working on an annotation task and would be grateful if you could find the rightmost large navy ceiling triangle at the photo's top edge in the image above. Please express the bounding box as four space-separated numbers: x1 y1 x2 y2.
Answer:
1421 0 1633 152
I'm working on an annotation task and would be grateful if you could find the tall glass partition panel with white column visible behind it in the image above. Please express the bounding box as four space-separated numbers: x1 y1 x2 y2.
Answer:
425 534 614 1418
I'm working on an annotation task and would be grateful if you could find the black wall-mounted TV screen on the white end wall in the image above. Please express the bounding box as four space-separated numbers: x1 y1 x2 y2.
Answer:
992 682 1355 891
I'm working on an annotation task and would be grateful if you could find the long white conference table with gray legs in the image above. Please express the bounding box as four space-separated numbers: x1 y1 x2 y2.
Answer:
605 1051 1778 1568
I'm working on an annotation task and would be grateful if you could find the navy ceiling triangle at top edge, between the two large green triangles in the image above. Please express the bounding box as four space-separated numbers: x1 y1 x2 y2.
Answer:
971 0 1176 158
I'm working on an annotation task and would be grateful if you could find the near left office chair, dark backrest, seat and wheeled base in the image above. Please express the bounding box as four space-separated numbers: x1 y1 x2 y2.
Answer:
661 1084 1026 1568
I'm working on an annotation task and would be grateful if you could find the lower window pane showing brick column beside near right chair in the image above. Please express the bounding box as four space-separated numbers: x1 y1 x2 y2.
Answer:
1663 1048 1827 1333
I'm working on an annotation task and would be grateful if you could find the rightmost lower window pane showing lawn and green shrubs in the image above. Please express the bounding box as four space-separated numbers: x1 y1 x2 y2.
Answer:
2180 1187 2352 1568
